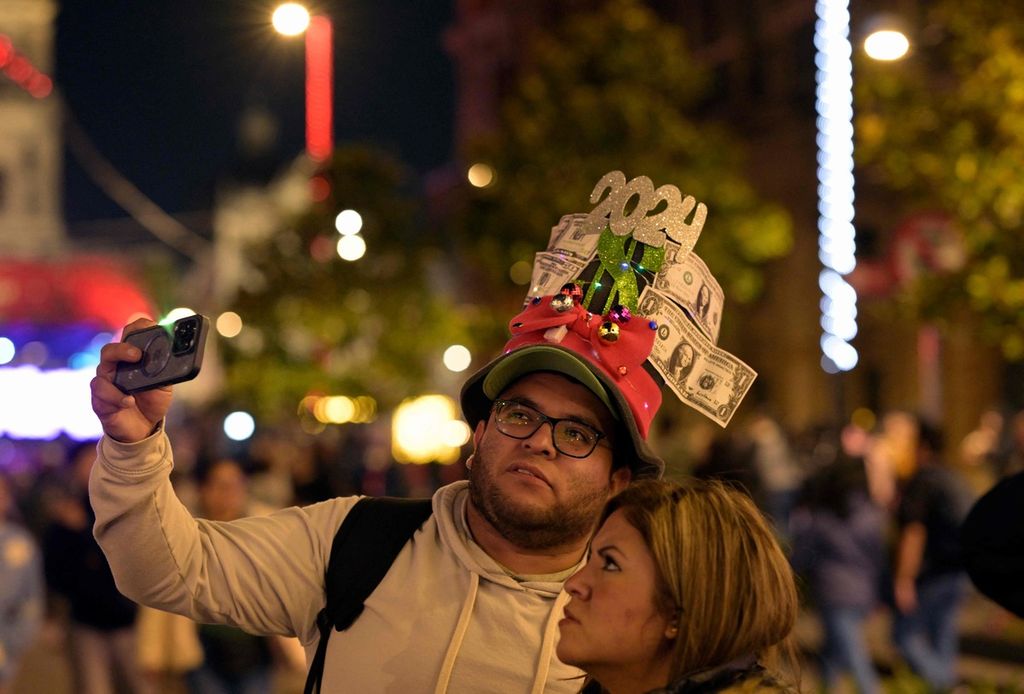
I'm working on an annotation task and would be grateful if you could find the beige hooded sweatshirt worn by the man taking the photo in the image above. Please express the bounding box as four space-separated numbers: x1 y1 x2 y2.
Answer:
89 432 582 694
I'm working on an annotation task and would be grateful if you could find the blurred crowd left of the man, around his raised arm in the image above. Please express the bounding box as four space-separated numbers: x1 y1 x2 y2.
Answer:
0 421 464 694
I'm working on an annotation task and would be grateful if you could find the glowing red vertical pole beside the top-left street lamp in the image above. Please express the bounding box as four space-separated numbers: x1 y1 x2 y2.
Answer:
306 16 334 162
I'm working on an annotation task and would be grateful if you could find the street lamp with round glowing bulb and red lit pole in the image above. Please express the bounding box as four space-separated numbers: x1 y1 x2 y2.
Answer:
271 2 334 162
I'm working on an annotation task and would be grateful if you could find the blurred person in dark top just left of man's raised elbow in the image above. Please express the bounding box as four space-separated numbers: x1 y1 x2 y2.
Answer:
43 441 153 694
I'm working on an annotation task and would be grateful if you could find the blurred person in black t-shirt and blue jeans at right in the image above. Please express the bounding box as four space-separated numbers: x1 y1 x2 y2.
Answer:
893 418 973 689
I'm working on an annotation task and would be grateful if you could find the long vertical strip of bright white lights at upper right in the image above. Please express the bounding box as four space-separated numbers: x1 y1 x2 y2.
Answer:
814 0 857 374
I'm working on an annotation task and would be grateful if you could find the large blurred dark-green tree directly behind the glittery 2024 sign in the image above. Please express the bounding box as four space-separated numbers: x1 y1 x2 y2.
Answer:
452 0 792 313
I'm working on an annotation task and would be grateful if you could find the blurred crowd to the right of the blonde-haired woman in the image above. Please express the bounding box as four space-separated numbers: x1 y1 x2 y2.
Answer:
691 409 1024 693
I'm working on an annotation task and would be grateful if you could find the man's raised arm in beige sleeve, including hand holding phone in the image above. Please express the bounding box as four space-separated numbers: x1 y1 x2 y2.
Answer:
89 320 355 643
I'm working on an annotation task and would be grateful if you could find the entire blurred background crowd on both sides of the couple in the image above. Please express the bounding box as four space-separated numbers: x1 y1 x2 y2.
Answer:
0 410 1024 694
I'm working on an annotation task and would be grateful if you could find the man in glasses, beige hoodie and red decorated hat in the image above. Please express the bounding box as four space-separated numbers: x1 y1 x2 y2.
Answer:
91 170 745 693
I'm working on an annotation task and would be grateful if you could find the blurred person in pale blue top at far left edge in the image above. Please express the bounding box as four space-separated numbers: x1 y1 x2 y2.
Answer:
0 474 45 694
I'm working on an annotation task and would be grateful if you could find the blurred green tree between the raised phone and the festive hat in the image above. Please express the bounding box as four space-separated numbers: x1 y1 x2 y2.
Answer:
225 147 475 418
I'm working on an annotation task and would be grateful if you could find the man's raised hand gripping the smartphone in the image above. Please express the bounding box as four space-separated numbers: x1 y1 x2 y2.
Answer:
89 318 171 443
